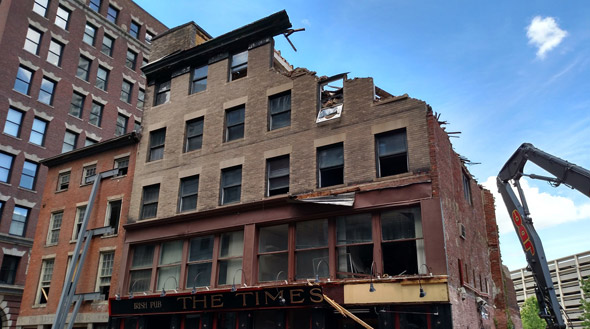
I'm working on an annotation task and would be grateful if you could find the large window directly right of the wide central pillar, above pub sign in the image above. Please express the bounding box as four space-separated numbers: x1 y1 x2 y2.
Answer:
258 224 289 282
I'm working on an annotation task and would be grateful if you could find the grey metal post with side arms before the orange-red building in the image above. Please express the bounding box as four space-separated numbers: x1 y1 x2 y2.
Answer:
51 169 119 329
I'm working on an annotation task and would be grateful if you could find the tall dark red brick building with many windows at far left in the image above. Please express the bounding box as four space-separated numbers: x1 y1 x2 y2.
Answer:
0 0 166 328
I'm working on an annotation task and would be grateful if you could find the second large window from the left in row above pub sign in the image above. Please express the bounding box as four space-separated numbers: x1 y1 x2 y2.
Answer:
156 240 183 290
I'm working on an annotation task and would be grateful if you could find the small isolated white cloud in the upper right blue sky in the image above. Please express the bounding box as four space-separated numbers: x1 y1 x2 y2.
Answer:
526 16 567 59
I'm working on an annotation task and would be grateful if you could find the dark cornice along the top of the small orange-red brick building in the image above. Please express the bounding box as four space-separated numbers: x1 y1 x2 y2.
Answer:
39 132 139 168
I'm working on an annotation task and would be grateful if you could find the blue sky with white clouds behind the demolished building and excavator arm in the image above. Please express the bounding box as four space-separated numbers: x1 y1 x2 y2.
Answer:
135 0 590 270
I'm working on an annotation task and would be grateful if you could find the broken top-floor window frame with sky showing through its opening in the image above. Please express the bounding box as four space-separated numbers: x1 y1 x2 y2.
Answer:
316 73 346 123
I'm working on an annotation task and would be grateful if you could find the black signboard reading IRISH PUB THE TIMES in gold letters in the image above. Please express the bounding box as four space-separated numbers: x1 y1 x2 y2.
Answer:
109 286 324 316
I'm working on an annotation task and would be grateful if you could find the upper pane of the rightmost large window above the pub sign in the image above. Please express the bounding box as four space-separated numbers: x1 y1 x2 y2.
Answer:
381 207 422 240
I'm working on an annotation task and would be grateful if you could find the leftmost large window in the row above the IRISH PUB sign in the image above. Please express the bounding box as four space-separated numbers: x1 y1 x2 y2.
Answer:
129 245 154 293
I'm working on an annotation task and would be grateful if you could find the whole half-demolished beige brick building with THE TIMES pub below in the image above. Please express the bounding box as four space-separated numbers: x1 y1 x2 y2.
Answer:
105 11 520 329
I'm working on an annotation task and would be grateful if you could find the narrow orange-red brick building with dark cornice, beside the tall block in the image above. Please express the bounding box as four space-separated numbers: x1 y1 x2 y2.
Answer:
17 132 139 328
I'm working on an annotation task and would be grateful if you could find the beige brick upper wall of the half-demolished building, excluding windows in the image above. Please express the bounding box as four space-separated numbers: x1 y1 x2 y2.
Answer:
129 43 430 221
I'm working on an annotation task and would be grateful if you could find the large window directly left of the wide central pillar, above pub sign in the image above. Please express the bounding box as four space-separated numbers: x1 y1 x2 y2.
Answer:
217 231 244 285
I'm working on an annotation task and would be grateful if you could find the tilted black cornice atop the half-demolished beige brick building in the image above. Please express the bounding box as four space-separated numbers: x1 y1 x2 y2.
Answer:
142 10 292 76
